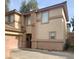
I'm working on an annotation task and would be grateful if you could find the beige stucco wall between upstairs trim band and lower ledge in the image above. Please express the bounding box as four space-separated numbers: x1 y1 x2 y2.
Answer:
36 18 64 40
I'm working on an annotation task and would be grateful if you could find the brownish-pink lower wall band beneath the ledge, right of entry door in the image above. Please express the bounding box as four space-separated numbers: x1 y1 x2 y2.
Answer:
32 41 64 50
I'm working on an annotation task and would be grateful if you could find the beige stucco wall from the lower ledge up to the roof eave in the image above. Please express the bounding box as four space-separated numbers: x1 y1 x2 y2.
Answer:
36 8 65 40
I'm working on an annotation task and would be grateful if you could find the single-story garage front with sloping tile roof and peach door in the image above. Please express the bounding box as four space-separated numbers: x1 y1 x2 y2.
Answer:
5 24 23 57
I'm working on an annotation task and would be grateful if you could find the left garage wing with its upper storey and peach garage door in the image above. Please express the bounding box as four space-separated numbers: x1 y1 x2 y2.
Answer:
5 12 23 58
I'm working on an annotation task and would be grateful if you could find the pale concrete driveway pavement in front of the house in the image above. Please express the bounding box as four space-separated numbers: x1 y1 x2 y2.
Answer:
11 50 74 59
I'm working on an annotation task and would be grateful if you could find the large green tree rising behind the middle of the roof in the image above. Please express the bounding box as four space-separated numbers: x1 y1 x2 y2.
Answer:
20 0 38 13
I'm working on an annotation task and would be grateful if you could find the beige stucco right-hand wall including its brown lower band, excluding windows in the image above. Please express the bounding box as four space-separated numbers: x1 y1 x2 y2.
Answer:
32 8 67 50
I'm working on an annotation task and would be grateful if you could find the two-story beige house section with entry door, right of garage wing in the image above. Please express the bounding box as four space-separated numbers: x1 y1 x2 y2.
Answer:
22 2 68 50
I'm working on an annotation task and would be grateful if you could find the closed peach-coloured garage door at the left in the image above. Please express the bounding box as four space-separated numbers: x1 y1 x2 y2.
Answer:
5 35 18 57
